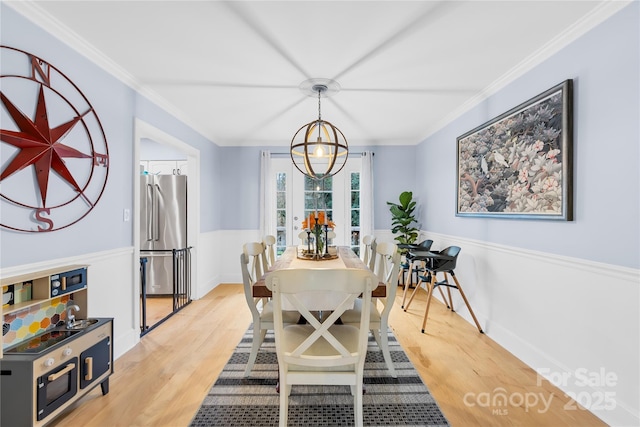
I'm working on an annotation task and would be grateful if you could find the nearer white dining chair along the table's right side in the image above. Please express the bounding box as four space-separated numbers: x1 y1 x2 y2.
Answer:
342 242 400 378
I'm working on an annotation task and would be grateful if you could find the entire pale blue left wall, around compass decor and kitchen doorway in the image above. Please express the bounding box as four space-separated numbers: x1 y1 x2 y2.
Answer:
0 4 223 268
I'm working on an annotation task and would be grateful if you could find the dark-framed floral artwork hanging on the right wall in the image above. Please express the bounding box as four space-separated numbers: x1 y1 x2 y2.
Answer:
456 80 573 221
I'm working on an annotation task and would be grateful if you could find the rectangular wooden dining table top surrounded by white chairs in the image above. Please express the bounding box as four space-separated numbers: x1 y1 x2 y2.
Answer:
252 246 387 298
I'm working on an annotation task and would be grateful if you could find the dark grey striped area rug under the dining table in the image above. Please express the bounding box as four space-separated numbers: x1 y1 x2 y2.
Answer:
191 329 449 427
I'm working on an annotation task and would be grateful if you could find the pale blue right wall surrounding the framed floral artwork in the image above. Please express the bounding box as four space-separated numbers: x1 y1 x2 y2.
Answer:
417 2 640 268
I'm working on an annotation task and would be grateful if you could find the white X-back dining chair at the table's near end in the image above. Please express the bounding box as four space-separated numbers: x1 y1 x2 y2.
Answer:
266 269 378 426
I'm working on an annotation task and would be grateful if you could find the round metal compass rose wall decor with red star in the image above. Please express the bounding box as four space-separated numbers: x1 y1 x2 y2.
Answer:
0 46 109 232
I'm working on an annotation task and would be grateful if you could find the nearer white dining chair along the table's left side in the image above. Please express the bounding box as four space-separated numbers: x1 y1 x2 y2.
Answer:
240 242 299 377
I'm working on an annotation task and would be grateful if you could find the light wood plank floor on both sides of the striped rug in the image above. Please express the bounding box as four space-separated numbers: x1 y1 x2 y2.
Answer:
52 285 605 427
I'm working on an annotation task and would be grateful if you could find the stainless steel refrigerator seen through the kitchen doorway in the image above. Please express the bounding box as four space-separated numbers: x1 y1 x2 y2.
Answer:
140 175 187 295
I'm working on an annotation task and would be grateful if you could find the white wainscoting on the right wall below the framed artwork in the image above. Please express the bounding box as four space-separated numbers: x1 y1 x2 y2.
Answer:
410 232 640 426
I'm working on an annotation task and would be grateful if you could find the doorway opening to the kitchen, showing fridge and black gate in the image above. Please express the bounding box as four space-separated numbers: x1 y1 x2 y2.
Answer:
133 120 200 337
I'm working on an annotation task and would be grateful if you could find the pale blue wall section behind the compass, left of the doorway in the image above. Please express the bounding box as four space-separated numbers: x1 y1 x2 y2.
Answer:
0 4 136 267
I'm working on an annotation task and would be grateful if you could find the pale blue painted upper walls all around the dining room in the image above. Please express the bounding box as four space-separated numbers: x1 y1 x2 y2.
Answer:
0 2 640 268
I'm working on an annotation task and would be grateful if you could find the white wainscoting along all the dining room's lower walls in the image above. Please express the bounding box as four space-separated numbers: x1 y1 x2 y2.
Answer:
11 230 640 425
